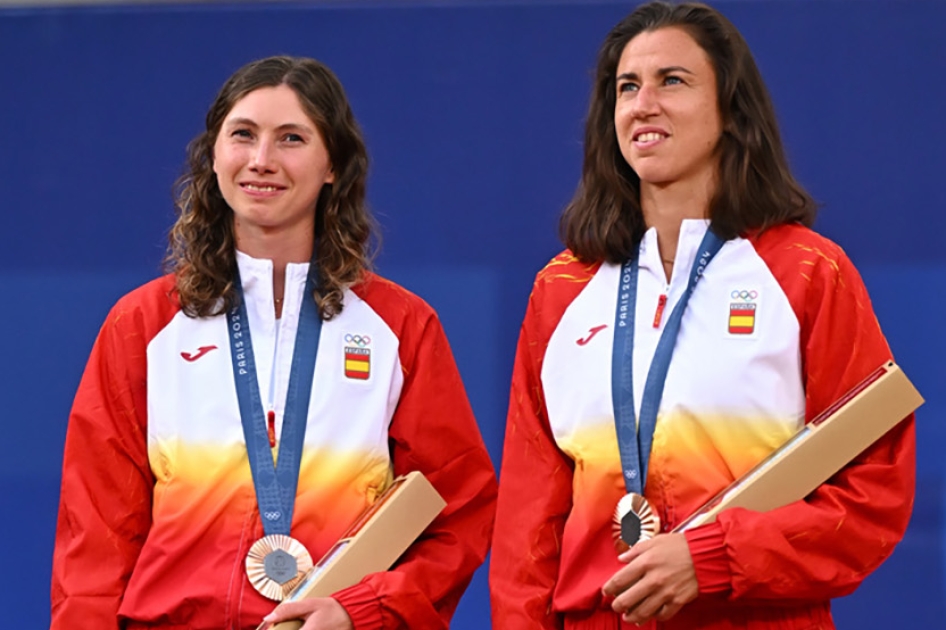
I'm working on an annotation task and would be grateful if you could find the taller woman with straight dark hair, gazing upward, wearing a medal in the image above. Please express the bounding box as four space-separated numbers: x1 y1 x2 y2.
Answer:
490 2 915 630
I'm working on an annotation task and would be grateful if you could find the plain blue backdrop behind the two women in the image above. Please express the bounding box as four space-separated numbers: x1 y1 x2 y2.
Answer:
0 0 946 629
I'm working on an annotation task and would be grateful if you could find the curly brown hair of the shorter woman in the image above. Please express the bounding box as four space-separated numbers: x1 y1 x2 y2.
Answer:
165 56 377 320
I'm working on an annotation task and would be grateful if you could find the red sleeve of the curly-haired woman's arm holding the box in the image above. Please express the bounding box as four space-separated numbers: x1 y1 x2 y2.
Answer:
334 282 496 630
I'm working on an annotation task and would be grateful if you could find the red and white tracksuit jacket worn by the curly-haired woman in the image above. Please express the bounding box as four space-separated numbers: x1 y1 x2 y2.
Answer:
52 254 496 630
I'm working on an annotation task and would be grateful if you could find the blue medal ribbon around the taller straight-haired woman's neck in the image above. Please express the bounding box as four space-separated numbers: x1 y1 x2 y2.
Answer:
611 226 723 495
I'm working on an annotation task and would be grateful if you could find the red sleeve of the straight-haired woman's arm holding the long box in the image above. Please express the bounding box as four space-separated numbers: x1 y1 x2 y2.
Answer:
695 228 915 601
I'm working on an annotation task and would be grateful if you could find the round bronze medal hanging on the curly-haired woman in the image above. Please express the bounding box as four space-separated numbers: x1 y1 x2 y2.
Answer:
246 534 312 602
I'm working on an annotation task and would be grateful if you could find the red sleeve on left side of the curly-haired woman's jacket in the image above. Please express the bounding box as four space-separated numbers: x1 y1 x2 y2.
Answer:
50 290 164 630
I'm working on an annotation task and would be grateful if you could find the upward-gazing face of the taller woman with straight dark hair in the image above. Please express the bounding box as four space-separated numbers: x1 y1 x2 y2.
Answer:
614 27 722 189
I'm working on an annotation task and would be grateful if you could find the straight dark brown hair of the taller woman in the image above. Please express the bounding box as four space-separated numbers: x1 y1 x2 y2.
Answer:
559 2 815 263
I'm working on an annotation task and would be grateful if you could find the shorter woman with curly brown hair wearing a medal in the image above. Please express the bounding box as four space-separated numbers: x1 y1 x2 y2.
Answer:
52 57 496 630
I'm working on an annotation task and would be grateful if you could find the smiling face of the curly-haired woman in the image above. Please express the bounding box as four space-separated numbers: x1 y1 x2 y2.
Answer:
213 85 334 247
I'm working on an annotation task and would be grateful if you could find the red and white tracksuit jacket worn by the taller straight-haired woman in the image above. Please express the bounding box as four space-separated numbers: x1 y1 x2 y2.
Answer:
490 221 915 630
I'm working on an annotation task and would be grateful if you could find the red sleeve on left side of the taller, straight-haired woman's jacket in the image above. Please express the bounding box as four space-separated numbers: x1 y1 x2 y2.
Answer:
489 253 592 630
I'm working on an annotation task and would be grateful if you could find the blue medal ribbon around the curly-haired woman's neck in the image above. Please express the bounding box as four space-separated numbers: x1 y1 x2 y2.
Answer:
227 256 322 536
